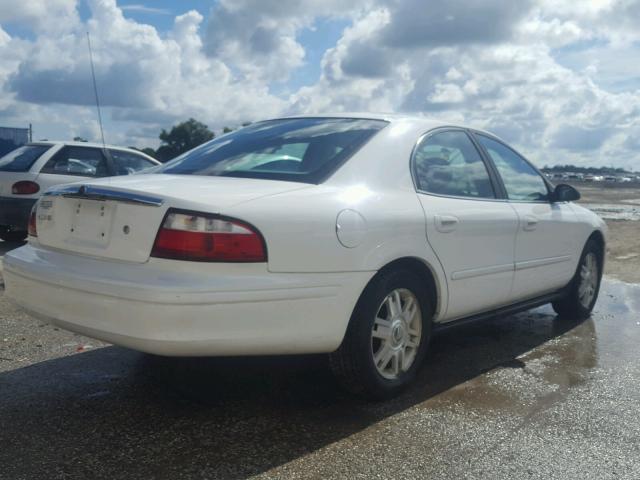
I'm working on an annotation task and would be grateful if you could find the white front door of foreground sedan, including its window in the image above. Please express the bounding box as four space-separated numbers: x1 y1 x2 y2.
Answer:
475 134 580 301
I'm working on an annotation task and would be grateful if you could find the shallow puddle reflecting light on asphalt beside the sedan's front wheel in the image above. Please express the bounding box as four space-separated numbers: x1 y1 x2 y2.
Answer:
425 278 640 412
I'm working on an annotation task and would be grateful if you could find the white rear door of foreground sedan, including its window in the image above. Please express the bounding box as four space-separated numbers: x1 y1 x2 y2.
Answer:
412 129 518 320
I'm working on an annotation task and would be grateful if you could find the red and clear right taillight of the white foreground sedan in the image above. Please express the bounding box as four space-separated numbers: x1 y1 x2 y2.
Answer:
151 212 267 262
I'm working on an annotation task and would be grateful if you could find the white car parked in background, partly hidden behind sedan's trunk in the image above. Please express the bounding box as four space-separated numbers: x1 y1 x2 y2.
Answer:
0 142 160 241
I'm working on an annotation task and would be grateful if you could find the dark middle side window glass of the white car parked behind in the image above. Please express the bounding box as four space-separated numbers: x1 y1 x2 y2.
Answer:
41 147 109 177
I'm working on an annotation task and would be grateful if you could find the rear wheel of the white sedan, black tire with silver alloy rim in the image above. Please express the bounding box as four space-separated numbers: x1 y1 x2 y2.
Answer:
329 269 433 400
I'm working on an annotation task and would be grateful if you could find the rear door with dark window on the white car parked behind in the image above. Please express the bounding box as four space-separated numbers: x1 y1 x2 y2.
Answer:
37 146 112 191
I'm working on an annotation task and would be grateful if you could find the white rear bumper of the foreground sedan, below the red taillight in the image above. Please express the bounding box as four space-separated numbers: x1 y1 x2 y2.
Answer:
3 245 373 356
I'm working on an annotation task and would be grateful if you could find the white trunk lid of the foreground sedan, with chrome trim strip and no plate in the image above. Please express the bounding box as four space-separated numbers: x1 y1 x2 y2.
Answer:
37 174 308 263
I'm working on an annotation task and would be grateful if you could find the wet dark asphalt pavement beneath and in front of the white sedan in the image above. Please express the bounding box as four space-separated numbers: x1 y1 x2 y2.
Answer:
0 253 640 480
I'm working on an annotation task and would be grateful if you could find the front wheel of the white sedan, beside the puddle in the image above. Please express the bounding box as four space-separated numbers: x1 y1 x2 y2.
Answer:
551 240 604 320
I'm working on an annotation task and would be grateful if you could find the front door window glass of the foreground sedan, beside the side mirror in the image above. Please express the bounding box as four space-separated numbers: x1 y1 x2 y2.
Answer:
476 135 549 202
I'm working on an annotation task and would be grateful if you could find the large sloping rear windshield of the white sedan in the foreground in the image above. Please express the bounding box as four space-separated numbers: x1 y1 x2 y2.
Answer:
154 118 387 183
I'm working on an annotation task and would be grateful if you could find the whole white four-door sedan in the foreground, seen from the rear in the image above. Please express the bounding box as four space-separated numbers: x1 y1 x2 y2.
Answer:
4 115 606 398
